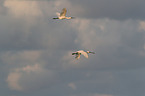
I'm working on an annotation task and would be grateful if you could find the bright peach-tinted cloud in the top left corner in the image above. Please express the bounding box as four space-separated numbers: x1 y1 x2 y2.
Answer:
4 0 42 17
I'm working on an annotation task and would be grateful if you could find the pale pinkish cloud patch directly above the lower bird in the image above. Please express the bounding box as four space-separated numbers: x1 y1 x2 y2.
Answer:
69 19 105 50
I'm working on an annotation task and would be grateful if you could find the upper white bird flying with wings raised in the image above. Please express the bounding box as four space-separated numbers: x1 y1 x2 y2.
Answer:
53 8 74 20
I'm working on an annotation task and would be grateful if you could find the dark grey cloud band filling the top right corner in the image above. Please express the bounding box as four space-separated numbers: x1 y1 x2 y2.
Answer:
70 0 145 20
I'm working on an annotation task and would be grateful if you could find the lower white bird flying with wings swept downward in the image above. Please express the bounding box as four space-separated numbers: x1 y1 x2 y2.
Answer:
72 50 95 60
